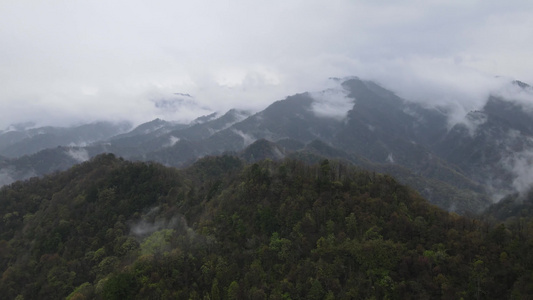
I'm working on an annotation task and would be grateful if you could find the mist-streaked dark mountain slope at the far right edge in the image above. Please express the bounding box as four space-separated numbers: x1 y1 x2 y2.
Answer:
432 96 533 195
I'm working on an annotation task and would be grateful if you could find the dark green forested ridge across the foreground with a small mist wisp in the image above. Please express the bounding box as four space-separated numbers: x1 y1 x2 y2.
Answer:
0 154 533 299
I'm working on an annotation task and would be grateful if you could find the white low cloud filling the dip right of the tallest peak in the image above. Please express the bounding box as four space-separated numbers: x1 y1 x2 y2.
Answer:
356 58 512 128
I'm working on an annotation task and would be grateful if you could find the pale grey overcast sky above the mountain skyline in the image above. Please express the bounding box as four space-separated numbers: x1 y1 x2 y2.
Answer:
0 0 533 128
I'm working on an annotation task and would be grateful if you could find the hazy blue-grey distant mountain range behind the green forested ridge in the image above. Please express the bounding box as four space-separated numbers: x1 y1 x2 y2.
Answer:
0 78 533 212
